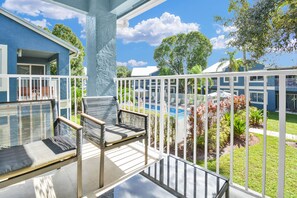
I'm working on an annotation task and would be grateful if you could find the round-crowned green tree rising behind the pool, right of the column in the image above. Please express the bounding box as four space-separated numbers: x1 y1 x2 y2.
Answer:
154 32 212 75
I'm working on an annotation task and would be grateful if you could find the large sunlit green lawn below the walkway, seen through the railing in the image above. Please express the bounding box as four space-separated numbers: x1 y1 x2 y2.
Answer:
199 135 297 197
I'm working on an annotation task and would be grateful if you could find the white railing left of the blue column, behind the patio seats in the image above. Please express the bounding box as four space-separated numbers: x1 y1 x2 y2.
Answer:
0 74 87 121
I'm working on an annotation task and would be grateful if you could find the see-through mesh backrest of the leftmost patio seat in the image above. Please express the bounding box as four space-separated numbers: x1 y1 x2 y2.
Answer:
0 100 57 149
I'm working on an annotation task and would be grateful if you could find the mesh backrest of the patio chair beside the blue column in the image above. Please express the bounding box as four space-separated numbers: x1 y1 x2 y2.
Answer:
83 96 118 125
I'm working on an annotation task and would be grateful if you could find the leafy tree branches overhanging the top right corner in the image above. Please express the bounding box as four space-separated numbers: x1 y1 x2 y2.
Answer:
222 0 297 60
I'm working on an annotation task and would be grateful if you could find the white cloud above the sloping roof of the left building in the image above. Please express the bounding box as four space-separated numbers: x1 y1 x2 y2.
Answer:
2 0 86 37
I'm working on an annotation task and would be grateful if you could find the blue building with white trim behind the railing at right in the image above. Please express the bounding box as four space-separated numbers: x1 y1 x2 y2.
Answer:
203 61 297 112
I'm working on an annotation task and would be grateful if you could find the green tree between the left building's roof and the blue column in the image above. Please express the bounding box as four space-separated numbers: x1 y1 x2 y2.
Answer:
51 24 85 76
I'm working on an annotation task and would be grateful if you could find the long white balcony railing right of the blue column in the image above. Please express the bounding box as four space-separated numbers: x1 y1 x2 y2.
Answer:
116 70 297 197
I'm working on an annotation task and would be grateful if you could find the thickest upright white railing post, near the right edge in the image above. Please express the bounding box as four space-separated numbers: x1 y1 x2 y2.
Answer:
277 75 286 198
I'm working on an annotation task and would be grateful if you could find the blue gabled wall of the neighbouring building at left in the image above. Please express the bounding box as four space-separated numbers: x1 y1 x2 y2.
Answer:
0 14 69 101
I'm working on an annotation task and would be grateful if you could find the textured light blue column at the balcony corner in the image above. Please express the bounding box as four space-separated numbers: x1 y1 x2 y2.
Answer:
86 0 117 96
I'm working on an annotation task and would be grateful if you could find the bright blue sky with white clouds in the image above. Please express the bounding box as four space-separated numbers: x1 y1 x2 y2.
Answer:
0 0 297 69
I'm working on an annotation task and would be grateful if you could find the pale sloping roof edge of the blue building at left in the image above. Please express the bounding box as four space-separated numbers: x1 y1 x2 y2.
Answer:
0 8 79 55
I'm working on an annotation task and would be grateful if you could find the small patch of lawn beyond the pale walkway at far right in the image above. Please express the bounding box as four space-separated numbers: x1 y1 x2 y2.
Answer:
267 112 297 135
